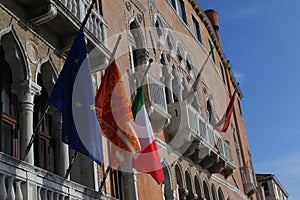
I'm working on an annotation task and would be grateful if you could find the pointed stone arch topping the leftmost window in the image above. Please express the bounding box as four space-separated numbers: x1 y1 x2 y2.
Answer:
0 24 31 82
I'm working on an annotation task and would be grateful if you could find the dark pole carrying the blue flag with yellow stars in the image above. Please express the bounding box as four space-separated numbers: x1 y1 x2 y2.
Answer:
23 0 96 160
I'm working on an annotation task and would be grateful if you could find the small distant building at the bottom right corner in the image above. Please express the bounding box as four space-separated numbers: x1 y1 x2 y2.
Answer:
256 174 289 200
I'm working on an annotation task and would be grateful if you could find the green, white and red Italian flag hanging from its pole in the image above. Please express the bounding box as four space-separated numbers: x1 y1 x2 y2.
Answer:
132 86 164 184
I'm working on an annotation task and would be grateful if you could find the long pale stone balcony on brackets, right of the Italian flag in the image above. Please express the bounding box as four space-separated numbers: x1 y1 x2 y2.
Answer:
166 102 235 177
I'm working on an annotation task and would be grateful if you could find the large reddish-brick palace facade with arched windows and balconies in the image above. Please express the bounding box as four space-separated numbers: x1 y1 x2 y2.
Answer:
0 0 260 200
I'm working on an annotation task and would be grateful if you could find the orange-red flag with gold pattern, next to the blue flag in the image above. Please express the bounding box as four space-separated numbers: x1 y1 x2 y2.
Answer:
96 60 141 168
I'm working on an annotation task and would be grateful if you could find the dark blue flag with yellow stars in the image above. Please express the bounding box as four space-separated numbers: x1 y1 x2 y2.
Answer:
49 25 103 164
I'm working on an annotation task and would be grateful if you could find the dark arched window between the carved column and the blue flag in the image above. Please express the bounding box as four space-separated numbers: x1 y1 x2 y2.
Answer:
33 74 55 172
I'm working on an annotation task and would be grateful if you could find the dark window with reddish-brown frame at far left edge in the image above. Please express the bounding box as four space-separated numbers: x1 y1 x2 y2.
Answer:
0 46 20 158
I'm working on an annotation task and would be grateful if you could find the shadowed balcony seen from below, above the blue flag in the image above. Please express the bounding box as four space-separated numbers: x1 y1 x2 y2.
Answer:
1 0 110 69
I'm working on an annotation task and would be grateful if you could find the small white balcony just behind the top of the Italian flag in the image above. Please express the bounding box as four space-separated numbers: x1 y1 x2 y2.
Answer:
131 71 171 133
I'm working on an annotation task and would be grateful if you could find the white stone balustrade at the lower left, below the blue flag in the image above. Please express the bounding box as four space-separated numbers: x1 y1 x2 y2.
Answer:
0 153 115 200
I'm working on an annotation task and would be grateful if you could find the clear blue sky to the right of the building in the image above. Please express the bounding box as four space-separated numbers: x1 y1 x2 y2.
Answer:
198 0 300 200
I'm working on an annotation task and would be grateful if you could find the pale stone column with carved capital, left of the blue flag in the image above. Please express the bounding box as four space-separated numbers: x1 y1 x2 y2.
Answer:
11 80 41 165
